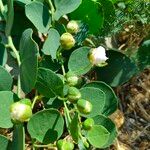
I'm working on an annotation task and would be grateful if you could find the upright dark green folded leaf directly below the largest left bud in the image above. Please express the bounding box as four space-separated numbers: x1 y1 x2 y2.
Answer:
12 123 25 150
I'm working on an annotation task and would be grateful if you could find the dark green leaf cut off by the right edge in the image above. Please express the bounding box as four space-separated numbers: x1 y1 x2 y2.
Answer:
136 40 150 71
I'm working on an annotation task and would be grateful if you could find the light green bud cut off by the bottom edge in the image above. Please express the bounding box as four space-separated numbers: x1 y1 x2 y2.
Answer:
56 140 74 150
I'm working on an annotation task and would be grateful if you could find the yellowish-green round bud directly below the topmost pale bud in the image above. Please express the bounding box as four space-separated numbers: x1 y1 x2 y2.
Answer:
60 33 75 50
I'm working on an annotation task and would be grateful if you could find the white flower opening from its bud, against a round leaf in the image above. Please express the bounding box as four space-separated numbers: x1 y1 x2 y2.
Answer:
89 46 108 67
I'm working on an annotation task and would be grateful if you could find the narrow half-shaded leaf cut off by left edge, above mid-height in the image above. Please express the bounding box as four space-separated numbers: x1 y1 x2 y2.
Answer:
0 43 7 66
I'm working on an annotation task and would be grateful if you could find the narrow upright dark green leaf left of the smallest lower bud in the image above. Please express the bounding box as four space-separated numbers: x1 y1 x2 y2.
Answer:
70 113 81 143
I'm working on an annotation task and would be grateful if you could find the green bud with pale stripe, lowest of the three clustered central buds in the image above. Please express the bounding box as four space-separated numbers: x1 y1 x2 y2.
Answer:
77 99 92 114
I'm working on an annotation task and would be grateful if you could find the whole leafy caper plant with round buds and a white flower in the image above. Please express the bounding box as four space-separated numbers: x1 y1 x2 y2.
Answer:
0 0 148 150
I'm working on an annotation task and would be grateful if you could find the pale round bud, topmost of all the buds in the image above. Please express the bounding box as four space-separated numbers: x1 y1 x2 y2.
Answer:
67 20 79 34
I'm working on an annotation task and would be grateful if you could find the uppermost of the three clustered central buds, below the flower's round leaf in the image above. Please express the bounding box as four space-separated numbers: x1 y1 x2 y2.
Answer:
65 71 82 86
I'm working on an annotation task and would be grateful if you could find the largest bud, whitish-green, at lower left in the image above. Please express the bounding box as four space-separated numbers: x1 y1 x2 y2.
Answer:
10 102 32 122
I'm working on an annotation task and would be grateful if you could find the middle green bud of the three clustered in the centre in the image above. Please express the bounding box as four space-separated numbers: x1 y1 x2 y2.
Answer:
67 87 81 103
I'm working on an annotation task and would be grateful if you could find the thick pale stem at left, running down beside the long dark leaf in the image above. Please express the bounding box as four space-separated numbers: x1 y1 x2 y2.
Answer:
7 36 21 98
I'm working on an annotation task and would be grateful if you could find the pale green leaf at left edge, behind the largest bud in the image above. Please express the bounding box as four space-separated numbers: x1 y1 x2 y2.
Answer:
0 91 14 128
